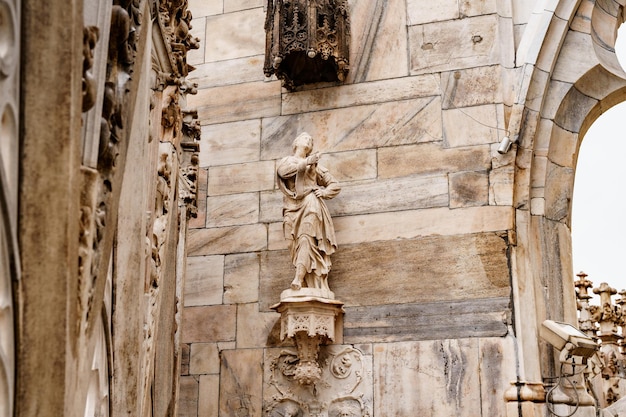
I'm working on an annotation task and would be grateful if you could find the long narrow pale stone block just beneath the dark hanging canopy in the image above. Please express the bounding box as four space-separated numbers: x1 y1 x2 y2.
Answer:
282 75 440 115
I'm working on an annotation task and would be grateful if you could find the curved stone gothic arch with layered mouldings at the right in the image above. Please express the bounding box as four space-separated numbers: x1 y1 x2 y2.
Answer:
500 0 626 394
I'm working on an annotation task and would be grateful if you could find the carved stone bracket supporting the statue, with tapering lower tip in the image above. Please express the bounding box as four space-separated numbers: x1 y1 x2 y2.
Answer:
272 291 344 385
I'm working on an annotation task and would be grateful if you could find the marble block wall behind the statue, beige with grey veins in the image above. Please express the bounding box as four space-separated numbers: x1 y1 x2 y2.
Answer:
179 0 527 417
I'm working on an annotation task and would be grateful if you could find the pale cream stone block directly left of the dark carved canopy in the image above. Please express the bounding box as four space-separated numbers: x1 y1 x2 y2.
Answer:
205 7 265 62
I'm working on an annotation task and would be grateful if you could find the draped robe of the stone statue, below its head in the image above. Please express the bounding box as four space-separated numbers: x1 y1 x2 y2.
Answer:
276 156 341 289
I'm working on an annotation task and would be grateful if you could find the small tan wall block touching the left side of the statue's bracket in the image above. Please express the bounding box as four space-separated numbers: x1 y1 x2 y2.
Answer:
237 300 280 349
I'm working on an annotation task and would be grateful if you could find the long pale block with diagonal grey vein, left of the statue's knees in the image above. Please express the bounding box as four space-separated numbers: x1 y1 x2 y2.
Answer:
187 224 267 256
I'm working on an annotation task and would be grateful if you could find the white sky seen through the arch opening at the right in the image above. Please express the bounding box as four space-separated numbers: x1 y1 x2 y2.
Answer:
572 25 626 291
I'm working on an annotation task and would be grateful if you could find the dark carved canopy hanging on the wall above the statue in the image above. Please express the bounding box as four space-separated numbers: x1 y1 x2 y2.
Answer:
264 0 350 90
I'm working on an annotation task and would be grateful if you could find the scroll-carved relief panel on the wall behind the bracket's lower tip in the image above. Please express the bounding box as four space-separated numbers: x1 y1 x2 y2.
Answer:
264 345 372 417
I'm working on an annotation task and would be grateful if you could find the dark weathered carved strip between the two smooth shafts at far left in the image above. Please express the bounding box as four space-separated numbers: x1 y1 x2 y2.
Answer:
78 1 141 329
